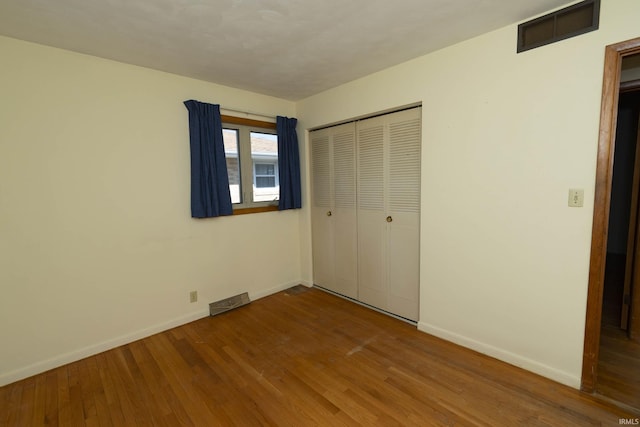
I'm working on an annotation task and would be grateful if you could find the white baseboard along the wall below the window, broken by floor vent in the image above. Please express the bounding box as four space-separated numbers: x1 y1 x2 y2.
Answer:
0 281 300 387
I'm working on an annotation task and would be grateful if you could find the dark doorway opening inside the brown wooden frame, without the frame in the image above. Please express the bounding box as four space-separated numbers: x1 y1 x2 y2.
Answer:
596 83 640 408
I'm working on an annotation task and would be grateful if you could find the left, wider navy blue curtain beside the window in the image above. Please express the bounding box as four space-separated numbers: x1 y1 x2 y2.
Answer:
184 100 233 218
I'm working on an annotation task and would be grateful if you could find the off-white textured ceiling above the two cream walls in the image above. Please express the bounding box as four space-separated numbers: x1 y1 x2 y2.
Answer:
0 0 568 100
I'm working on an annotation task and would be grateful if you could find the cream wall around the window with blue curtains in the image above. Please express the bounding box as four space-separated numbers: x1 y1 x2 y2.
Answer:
0 37 301 385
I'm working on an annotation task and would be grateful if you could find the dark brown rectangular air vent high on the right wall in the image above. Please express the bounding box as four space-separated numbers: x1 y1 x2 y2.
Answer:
518 0 600 53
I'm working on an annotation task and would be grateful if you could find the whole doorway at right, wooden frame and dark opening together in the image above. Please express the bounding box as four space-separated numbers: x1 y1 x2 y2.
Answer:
581 38 640 409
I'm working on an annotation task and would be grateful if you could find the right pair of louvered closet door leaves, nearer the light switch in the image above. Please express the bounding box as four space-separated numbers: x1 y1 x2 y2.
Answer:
357 108 421 320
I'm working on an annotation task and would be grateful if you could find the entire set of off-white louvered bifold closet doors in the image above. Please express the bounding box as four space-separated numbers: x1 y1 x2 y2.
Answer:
310 108 421 320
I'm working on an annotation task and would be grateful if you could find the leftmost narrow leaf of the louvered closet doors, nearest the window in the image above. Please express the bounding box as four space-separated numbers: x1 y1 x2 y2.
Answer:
310 129 334 289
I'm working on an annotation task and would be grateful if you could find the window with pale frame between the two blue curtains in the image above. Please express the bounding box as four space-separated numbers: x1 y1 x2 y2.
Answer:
222 118 280 210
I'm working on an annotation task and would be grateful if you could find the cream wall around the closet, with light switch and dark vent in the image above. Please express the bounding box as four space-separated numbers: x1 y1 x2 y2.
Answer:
297 0 640 387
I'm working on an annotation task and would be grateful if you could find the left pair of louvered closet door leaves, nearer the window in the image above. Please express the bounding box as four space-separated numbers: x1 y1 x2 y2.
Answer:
310 123 358 298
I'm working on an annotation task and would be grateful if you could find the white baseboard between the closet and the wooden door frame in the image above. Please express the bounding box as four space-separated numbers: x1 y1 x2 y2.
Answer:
418 322 581 390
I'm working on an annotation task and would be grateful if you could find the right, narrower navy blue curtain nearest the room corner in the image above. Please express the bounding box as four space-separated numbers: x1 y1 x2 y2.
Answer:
276 116 302 211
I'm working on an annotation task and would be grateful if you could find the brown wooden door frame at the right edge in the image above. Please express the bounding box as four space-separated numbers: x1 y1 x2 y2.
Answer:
581 38 640 393
